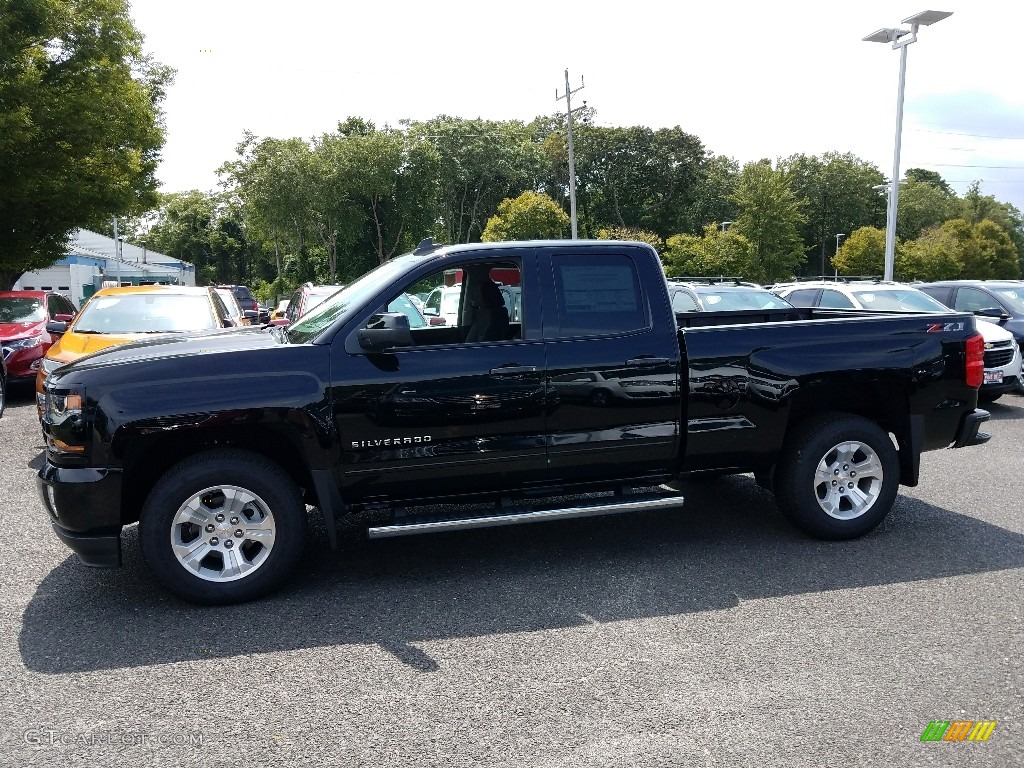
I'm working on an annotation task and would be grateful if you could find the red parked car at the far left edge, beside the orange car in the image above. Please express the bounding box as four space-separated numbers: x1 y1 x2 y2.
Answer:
0 291 78 382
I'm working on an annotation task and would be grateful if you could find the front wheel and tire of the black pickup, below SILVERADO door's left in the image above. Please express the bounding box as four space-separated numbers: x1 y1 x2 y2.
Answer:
139 449 307 605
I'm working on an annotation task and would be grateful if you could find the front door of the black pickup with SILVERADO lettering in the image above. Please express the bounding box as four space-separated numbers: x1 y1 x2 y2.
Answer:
332 256 546 500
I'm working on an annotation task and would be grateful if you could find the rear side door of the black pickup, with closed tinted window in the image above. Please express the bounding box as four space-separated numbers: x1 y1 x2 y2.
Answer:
541 245 682 482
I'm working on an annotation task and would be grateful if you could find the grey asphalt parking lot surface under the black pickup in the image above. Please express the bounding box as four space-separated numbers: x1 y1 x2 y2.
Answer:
0 391 1024 768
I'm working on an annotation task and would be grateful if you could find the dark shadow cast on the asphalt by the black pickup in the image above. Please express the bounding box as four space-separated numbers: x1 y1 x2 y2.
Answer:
19 476 1024 674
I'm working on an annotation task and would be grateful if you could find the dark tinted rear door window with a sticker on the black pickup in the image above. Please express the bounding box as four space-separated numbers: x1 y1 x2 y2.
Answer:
546 254 648 337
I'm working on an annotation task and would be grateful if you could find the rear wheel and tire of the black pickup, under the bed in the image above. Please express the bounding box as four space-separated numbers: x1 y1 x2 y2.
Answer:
774 414 899 541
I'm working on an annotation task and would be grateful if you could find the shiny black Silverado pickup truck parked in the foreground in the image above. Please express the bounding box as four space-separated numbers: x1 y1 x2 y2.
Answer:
39 241 988 603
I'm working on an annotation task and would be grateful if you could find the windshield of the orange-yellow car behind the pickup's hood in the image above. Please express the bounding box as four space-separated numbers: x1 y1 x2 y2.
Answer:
72 293 219 334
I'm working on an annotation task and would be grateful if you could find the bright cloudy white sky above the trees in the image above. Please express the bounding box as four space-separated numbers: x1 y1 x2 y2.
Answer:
131 0 1024 210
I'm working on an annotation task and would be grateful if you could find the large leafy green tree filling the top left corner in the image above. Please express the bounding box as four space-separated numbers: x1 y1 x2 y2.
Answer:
0 0 172 289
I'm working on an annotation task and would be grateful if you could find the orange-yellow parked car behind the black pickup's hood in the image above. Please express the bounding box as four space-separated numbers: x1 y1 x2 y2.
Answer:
36 286 240 415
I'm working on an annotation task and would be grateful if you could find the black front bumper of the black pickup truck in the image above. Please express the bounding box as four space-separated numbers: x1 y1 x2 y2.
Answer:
36 461 122 568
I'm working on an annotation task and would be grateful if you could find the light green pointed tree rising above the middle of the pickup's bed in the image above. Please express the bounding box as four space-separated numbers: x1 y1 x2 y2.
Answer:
730 160 806 283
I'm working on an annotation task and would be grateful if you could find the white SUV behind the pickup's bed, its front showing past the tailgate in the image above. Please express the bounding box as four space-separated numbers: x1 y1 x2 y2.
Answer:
772 281 1024 402
